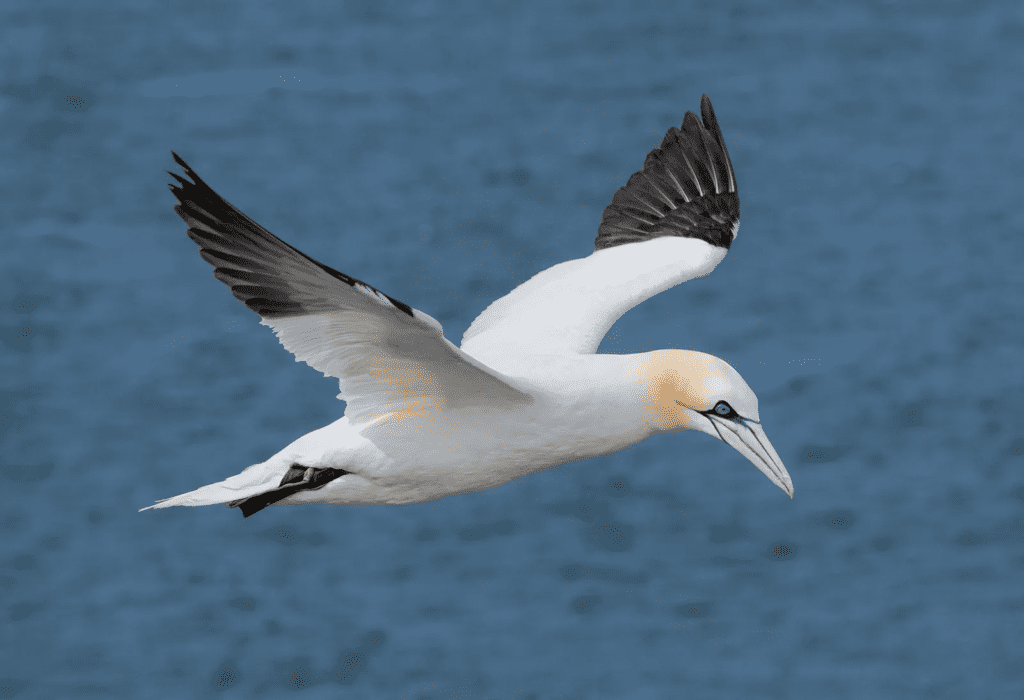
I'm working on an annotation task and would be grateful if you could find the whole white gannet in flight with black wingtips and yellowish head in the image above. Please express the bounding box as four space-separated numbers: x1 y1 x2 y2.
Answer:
142 95 793 518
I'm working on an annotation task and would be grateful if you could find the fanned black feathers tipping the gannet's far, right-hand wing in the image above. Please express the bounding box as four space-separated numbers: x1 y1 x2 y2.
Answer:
594 95 739 250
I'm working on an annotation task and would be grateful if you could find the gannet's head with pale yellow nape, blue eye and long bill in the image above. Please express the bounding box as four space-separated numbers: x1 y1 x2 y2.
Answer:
638 350 793 498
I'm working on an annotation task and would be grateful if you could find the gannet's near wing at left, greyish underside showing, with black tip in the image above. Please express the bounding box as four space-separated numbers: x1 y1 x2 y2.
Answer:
170 154 530 423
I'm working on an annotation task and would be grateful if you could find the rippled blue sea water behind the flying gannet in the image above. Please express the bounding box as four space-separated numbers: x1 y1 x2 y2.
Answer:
0 0 1024 700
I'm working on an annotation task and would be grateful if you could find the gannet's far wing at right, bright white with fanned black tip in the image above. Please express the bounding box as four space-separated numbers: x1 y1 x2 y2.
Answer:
462 95 739 358
